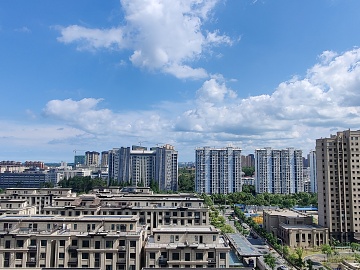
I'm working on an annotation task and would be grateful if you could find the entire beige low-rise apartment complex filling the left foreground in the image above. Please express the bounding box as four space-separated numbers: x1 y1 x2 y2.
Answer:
0 187 230 270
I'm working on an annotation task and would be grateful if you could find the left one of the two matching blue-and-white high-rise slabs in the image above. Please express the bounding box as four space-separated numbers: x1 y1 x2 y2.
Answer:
195 147 241 194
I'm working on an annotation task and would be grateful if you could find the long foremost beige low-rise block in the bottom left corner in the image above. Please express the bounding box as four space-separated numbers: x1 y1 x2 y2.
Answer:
0 215 147 270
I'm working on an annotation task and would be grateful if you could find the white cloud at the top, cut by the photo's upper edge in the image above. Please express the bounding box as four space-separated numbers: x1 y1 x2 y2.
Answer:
58 0 233 79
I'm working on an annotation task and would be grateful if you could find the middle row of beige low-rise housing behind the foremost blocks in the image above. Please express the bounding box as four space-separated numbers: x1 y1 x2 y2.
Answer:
43 190 209 233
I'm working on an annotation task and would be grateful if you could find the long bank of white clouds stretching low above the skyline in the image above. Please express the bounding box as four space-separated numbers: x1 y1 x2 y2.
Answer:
37 49 360 156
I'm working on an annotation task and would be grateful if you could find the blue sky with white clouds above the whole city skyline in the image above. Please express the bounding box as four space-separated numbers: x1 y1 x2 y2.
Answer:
0 0 360 162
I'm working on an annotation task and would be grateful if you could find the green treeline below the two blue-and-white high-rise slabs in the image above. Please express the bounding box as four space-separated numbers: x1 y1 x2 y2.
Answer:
202 188 317 208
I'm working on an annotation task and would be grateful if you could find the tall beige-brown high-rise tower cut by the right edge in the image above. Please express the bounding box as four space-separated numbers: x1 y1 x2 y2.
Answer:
316 130 360 242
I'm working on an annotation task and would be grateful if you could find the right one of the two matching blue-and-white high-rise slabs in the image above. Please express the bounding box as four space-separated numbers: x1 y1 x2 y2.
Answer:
255 147 304 194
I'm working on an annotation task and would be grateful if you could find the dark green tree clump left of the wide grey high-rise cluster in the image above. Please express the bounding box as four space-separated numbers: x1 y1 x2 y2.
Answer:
58 176 107 193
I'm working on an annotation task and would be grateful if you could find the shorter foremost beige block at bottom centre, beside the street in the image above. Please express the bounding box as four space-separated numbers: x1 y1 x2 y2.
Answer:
145 226 230 268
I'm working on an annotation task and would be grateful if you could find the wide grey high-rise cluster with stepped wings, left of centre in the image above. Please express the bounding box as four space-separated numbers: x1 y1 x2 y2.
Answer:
109 144 178 191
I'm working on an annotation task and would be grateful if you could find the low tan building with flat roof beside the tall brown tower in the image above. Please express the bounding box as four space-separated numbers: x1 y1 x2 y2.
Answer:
263 210 329 248
